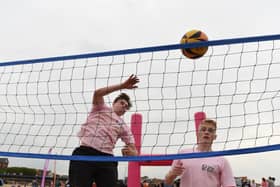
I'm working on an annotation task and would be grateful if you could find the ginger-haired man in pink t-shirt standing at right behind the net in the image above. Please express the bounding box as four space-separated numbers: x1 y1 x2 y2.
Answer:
165 119 236 187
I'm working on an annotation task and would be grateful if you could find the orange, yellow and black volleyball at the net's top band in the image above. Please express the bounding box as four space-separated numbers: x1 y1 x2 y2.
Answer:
180 30 208 59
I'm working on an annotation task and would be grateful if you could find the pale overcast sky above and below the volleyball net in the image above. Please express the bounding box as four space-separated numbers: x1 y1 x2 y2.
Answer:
0 0 280 184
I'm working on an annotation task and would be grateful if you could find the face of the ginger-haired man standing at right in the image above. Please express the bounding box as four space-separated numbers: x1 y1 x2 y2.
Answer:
198 122 217 145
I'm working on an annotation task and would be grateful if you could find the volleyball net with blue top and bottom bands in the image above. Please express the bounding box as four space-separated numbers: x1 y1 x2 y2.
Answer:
0 35 280 161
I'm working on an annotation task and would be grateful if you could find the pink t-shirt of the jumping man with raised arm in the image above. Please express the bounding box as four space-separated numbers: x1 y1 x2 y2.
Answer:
78 104 134 154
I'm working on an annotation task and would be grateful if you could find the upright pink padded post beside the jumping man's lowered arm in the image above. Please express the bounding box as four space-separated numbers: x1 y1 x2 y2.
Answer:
127 114 142 187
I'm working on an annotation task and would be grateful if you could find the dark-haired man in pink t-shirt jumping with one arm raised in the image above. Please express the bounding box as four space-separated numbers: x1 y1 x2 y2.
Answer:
69 75 139 187
